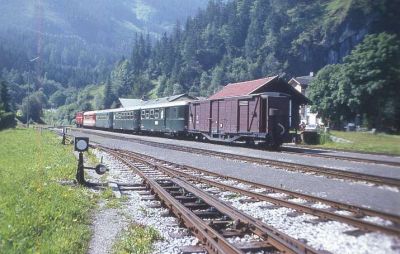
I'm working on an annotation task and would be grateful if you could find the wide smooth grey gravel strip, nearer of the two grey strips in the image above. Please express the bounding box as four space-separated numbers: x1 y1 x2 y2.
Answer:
69 133 400 215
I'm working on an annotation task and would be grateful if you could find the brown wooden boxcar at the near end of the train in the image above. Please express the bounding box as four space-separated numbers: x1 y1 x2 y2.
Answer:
189 93 291 145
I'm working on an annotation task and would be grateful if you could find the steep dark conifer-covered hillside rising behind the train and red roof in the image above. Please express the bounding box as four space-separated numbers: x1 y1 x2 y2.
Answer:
105 0 400 97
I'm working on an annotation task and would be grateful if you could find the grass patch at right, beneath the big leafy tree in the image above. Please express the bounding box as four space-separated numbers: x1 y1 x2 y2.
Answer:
319 131 400 155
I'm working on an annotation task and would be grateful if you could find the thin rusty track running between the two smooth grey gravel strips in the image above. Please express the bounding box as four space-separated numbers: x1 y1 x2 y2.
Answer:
71 129 400 188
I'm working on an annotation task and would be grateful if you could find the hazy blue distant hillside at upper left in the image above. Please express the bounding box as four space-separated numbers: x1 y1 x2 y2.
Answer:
0 0 207 87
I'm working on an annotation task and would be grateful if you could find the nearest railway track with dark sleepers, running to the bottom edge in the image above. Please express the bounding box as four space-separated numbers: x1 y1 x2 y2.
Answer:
101 148 319 253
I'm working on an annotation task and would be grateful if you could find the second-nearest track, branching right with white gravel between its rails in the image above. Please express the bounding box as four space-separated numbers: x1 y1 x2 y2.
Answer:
101 148 400 237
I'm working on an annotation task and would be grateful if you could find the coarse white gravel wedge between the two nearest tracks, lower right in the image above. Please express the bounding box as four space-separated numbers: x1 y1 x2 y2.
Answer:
202 184 400 254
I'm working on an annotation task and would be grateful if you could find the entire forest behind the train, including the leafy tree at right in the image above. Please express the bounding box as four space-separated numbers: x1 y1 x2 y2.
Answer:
0 0 400 131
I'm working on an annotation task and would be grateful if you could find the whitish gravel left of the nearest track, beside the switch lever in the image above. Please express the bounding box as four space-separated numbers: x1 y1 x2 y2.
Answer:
88 150 198 254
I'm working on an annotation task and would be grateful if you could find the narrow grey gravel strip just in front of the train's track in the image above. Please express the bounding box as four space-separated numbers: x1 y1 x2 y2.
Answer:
72 130 400 179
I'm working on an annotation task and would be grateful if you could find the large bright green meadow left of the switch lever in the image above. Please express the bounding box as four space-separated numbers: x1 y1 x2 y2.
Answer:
0 129 96 253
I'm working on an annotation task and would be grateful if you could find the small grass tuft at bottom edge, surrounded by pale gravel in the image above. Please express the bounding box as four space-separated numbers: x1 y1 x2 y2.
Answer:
114 224 161 254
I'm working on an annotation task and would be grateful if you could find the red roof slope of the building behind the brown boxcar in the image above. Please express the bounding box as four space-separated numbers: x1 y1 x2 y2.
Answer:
208 76 277 100
